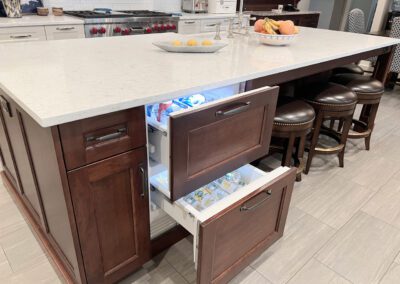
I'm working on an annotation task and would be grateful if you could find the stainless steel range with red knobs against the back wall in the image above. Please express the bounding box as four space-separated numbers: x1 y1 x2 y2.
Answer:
64 10 179 38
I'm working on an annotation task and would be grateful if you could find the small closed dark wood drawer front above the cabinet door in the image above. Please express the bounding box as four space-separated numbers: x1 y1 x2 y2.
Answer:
60 107 146 170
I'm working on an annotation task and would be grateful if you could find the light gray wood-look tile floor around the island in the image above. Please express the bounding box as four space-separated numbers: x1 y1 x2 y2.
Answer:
0 89 400 284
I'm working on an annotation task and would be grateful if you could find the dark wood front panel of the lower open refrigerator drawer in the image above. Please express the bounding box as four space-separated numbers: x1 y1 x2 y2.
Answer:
197 168 296 283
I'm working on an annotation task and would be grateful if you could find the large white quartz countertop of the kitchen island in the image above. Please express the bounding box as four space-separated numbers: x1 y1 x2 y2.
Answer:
0 28 400 127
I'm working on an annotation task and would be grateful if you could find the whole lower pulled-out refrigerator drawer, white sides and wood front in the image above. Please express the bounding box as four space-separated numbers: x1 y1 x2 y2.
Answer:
151 165 296 283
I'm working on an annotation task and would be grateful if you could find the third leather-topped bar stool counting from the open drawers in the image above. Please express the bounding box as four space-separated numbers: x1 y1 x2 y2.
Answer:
331 74 385 150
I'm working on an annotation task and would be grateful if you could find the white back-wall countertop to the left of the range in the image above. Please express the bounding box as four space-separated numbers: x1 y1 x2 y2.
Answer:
0 15 83 28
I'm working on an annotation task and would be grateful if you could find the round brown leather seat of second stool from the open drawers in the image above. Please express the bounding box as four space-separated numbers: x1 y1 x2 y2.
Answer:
302 83 357 106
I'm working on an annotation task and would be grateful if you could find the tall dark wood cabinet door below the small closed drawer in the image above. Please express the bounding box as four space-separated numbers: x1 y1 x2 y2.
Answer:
68 147 150 284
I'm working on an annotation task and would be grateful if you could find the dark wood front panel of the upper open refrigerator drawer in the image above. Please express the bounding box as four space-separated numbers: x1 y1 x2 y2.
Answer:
170 87 279 201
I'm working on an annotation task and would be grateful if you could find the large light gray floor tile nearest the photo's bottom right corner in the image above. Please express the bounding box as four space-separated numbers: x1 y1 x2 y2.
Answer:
316 212 400 284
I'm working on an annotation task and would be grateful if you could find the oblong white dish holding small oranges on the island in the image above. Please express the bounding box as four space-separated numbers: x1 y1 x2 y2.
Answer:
153 38 228 53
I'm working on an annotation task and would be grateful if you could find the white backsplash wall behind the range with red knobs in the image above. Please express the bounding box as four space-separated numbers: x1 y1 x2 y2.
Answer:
43 0 153 10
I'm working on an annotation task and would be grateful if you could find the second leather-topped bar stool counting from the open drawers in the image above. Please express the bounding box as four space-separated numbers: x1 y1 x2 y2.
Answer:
300 83 357 174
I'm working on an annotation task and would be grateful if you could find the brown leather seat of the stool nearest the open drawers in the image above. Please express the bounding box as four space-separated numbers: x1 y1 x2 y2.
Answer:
274 96 315 125
